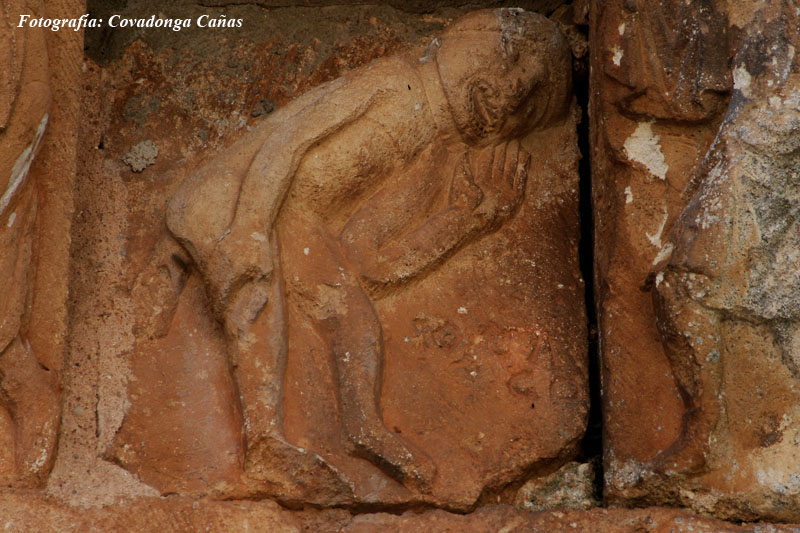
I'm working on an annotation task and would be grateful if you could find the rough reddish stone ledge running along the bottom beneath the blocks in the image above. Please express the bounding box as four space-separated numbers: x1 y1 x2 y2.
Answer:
0 493 797 533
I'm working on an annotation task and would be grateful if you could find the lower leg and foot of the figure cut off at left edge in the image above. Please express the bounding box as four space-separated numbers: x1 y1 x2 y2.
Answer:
0 337 61 486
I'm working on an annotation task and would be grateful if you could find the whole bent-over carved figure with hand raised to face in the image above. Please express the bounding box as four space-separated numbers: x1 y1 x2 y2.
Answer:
111 9 572 500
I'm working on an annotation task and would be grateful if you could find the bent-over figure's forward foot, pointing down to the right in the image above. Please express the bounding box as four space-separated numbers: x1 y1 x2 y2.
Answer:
345 423 436 493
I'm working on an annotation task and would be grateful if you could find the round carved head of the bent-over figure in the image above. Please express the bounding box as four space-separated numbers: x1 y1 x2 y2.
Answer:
435 8 572 144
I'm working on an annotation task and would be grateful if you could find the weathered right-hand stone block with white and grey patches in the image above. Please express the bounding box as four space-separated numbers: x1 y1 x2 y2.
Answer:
592 2 800 520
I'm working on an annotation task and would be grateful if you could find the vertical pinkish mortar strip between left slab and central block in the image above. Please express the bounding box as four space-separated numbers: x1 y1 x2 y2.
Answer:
46 51 162 507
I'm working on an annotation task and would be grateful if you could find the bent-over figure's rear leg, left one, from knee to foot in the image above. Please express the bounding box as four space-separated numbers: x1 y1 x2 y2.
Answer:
203 231 353 503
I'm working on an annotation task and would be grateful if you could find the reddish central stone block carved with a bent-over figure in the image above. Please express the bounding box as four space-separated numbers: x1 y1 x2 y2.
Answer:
100 9 587 508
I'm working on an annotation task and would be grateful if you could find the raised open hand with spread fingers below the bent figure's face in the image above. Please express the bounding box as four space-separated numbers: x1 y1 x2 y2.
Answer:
472 140 531 227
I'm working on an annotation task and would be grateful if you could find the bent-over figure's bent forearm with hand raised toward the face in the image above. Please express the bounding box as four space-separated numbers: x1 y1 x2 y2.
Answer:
341 137 530 287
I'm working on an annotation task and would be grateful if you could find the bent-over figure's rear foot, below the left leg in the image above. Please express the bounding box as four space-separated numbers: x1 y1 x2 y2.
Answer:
245 434 354 505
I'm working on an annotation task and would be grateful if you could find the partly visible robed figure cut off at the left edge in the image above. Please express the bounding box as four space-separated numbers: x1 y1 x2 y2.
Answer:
0 2 59 485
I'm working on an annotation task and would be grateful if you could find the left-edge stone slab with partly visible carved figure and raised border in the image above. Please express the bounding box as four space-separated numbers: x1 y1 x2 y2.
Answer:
0 1 82 486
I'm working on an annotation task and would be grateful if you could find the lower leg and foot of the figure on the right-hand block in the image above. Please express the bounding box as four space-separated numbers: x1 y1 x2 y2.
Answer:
653 272 724 473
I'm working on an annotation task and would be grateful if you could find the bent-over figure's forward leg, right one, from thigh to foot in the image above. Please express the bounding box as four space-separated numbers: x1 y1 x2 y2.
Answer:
281 217 436 491
